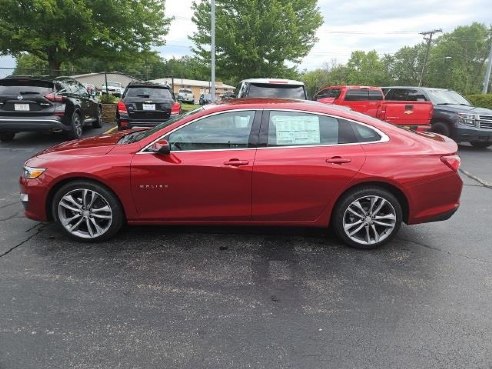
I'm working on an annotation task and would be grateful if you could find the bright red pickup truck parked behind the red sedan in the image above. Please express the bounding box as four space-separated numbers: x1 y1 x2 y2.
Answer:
314 86 433 131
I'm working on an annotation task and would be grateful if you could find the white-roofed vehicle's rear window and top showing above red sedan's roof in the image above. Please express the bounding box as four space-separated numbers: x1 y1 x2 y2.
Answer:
236 78 307 100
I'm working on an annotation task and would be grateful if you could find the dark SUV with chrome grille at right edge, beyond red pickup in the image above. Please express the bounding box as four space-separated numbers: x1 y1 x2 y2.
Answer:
383 86 492 148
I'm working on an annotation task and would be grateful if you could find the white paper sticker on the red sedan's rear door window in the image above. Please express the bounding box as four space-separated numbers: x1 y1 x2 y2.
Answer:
271 115 321 145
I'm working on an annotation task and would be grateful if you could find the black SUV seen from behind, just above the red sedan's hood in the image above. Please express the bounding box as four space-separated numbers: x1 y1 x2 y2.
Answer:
116 82 181 130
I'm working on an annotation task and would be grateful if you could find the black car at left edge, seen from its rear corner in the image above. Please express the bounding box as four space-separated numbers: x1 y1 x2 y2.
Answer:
0 76 101 142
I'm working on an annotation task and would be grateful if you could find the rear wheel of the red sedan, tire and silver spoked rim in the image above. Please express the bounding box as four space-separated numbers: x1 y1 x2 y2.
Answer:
332 186 402 249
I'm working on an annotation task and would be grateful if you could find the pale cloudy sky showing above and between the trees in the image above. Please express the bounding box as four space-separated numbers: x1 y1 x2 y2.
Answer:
0 0 492 75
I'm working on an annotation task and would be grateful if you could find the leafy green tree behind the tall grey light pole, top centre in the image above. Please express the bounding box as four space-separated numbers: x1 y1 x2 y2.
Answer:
190 0 323 81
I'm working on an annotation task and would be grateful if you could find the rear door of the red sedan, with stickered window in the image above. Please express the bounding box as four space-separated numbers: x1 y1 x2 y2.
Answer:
252 111 365 223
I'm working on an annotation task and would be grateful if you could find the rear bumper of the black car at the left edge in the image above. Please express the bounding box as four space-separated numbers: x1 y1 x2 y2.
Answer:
0 116 70 132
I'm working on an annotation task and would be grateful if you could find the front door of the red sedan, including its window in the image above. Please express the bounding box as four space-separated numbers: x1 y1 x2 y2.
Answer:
132 111 256 222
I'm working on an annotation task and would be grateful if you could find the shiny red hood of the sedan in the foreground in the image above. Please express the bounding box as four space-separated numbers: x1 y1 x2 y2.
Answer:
36 132 128 156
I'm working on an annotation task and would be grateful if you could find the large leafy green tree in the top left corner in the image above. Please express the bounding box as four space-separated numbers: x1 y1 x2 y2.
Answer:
0 0 171 74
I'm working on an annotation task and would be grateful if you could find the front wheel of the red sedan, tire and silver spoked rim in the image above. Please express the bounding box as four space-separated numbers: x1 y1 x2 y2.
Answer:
51 180 124 242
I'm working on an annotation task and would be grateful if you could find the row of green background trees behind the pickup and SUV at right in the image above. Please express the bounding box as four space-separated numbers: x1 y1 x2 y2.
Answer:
302 23 492 96
